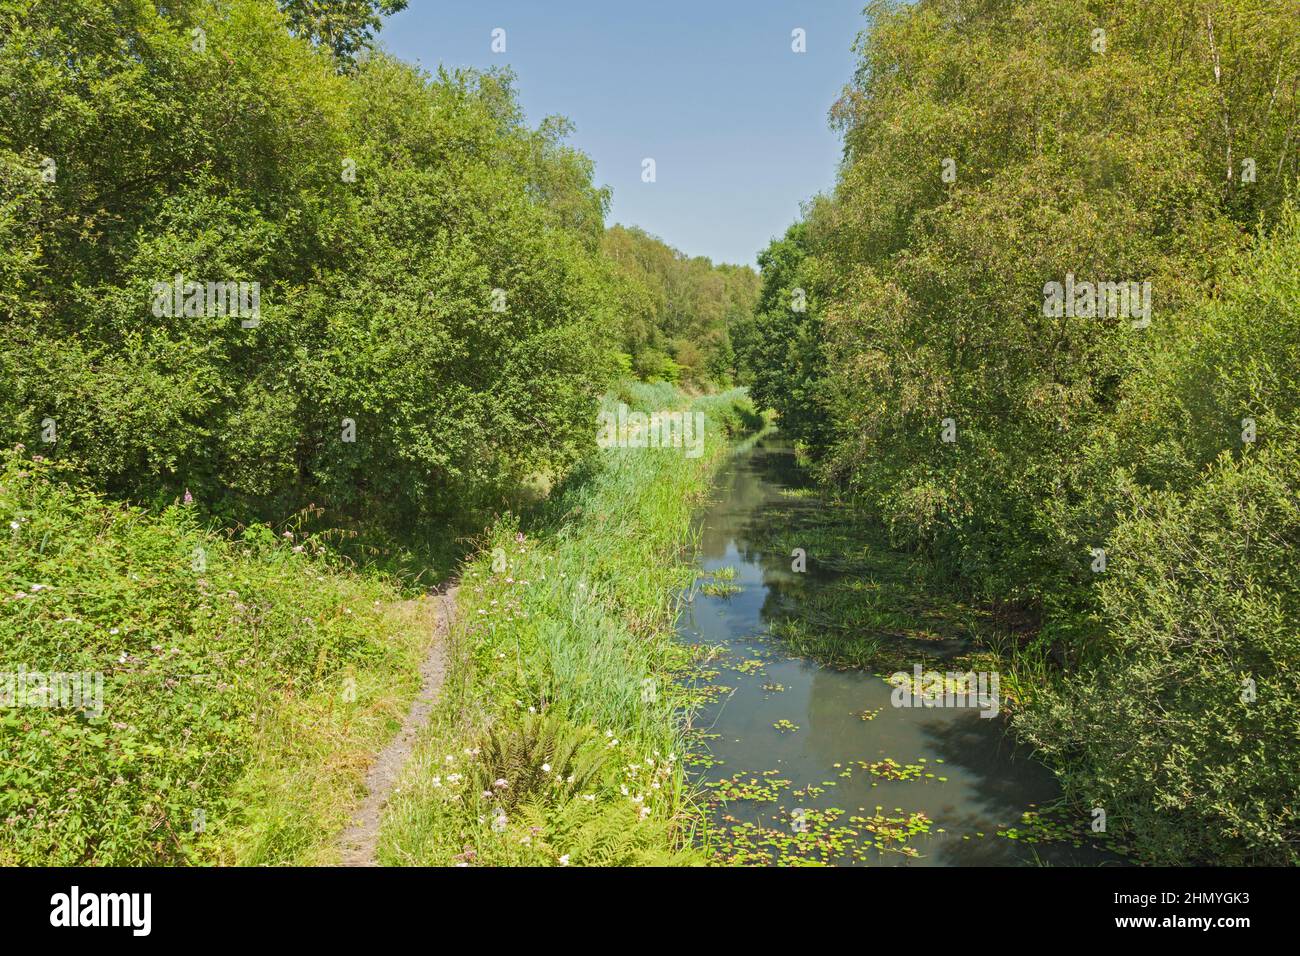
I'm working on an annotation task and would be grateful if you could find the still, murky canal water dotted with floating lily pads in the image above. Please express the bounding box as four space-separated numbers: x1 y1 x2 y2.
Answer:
677 433 1109 866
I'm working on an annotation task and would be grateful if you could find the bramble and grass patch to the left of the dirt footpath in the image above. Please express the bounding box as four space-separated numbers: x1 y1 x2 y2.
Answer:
0 451 430 865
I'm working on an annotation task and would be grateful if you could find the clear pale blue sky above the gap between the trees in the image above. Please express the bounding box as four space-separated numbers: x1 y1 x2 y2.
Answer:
380 0 866 263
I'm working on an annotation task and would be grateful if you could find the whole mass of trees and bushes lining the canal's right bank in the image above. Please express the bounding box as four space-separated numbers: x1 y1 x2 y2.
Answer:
741 0 1300 865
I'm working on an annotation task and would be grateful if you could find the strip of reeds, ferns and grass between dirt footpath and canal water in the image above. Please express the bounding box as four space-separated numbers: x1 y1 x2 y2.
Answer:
380 385 758 865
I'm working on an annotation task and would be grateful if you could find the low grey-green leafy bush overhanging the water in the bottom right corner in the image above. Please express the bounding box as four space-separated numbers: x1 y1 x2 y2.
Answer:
1021 432 1300 866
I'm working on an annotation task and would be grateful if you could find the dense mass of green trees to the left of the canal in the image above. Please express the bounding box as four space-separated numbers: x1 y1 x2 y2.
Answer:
0 0 758 528
